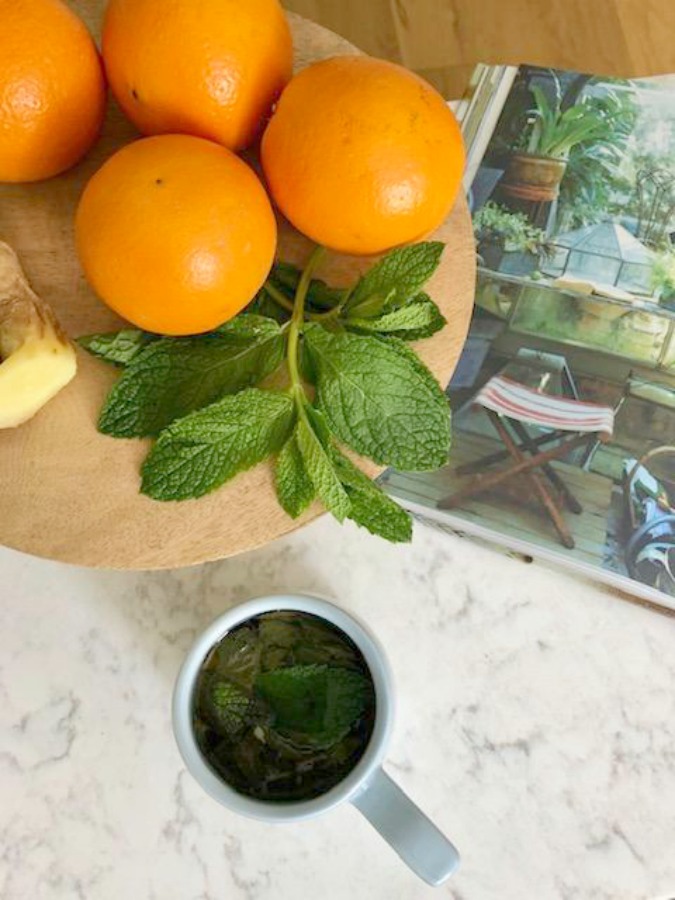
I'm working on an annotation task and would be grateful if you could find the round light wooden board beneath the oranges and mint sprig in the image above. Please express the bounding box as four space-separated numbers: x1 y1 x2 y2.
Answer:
0 0 475 569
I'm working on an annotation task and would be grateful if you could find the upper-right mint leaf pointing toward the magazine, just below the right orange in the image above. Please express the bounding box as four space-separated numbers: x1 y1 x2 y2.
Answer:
345 241 445 318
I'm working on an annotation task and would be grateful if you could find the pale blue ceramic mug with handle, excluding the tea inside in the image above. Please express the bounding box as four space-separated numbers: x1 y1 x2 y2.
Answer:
173 594 459 885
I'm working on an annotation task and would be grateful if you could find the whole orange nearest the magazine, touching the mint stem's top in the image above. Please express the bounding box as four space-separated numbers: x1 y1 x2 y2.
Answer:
262 56 464 254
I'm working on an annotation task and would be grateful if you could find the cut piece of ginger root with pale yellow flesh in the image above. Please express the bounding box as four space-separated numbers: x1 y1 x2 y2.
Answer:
0 241 77 428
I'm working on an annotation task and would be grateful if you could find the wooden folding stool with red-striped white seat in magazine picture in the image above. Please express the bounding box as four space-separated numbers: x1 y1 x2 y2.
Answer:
438 375 614 549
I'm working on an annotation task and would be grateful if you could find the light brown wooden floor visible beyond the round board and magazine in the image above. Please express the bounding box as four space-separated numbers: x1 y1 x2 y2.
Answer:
285 0 675 99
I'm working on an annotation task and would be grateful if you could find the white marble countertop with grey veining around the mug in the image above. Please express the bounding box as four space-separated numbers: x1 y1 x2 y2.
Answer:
0 518 675 900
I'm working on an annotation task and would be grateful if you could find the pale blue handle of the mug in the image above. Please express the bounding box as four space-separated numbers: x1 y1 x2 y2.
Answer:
351 768 459 886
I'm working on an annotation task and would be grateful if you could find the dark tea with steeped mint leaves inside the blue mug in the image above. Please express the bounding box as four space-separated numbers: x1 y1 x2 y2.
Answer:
193 612 375 802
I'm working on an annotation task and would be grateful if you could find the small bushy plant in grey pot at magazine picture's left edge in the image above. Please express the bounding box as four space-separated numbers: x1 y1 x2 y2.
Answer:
473 203 548 275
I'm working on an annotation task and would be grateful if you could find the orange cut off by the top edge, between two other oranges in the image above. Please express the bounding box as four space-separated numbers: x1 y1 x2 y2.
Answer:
103 0 293 150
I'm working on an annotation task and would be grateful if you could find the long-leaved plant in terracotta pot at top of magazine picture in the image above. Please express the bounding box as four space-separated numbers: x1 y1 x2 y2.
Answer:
502 81 620 201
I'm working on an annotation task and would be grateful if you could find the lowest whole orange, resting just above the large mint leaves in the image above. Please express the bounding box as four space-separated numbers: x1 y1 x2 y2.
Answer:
75 134 277 334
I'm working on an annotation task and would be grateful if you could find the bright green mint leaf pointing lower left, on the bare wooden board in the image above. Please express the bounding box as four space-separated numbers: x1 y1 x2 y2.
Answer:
141 388 294 500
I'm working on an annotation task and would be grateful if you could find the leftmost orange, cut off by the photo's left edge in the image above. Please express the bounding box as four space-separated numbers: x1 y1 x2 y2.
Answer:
0 0 105 181
